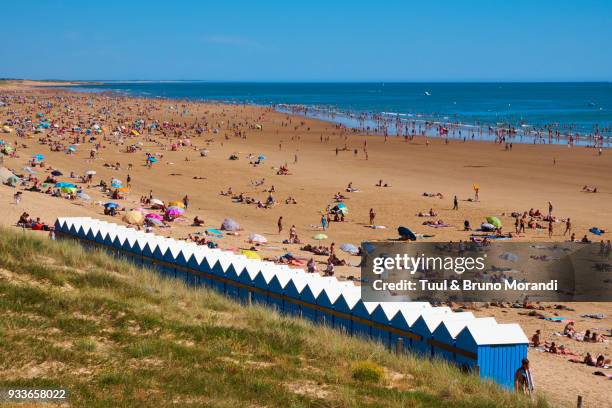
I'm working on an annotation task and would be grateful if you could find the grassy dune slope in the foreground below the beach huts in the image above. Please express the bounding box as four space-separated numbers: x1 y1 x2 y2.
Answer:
0 229 548 408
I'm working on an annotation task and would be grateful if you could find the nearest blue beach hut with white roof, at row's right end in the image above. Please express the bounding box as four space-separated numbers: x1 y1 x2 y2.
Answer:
456 324 529 389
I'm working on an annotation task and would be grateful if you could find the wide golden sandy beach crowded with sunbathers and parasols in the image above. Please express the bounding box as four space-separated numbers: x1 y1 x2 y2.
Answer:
0 83 612 407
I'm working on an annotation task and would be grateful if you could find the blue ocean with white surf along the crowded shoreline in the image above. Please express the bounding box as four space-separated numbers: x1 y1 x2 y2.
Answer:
67 81 612 147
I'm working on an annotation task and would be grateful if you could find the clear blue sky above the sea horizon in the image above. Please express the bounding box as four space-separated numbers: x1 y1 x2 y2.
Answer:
0 0 612 81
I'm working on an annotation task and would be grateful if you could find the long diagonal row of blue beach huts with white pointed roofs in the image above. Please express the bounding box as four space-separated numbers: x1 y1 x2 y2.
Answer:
55 217 528 388
